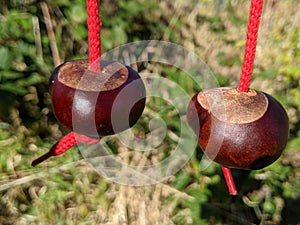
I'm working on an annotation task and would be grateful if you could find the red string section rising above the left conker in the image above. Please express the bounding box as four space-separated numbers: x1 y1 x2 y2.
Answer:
86 0 102 71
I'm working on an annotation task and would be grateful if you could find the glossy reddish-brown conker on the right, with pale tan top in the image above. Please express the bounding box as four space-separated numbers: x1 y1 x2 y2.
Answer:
187 87 289 169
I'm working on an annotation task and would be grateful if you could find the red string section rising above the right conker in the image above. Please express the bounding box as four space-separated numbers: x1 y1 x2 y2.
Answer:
238 0 263 92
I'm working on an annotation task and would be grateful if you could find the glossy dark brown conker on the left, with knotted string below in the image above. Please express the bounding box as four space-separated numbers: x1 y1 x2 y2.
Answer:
50 60 146 136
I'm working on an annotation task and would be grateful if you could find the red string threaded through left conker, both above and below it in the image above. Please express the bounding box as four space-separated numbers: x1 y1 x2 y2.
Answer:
31 0 102 166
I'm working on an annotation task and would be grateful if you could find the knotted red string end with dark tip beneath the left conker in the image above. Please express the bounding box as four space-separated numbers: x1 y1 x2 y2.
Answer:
31 131 99 166
